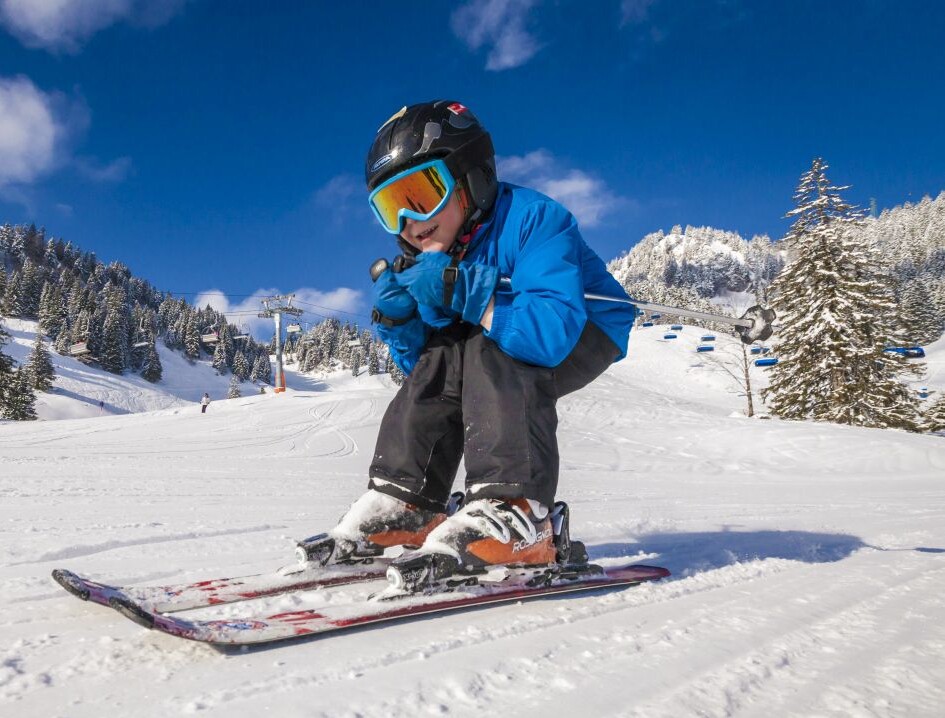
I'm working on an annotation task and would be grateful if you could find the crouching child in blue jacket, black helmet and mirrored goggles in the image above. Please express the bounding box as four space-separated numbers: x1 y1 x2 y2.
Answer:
310 100 635 588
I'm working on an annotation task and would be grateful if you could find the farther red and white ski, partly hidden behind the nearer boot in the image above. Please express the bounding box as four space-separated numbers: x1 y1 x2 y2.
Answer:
52 560 387 613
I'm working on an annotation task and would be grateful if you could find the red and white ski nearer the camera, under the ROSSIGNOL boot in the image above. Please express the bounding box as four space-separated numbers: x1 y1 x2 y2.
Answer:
101 565 669 646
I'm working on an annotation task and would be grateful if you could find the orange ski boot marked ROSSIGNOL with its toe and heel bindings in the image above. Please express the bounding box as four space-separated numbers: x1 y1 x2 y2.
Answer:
387 499 596 593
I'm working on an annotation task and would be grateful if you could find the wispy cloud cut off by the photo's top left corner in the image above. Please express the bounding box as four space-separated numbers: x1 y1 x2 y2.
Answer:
0 0 187 52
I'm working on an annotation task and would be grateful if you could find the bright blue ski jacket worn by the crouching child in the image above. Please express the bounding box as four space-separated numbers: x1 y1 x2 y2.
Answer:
377 182 636 374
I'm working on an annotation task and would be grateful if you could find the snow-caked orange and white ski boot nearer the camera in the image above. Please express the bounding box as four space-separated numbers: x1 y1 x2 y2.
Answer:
387 499 558 591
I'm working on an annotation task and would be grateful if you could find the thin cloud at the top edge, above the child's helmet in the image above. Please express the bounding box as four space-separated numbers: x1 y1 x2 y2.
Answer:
450 0 541 70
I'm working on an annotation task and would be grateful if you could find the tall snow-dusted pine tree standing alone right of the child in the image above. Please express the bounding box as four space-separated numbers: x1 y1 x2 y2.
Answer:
765 158 917 430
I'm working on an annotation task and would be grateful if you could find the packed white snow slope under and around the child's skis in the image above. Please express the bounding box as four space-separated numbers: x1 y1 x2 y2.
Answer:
0 327 945 718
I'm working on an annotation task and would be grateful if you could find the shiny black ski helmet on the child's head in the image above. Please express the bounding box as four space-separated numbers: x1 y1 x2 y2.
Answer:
364 100 498 238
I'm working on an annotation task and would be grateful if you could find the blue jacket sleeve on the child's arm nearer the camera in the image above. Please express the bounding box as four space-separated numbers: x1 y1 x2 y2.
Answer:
486 201 587 367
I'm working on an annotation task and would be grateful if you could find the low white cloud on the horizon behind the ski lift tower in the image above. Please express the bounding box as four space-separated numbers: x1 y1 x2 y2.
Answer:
193 287 370 341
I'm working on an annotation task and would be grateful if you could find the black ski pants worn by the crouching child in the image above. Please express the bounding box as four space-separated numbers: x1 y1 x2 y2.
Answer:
369 321 619 509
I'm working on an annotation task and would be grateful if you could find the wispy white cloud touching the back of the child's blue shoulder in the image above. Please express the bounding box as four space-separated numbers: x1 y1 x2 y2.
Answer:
498 149 636 227
